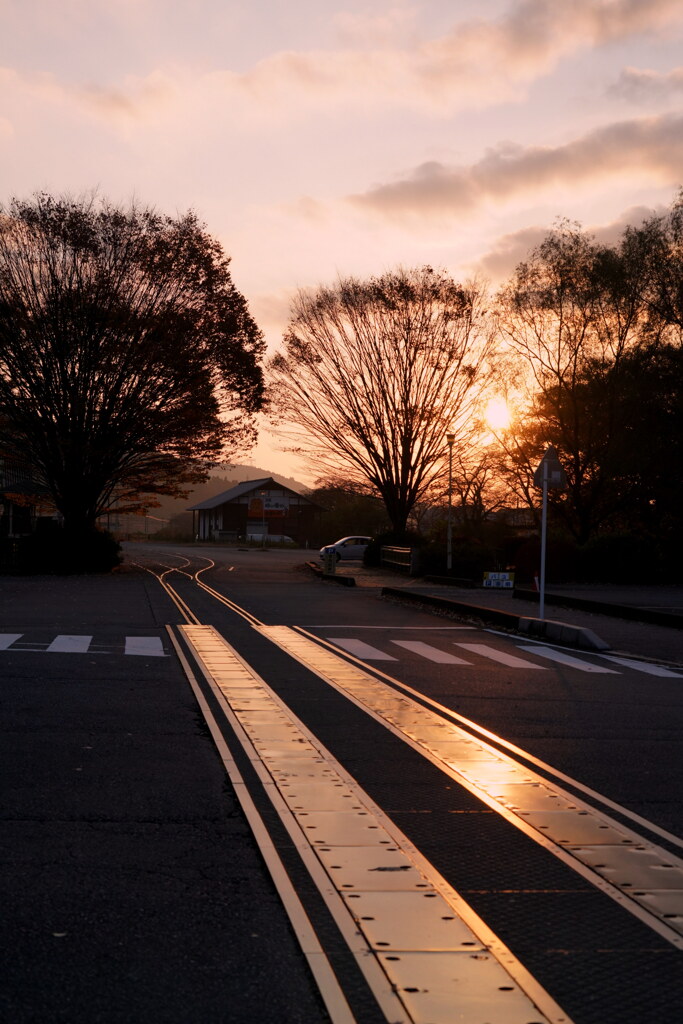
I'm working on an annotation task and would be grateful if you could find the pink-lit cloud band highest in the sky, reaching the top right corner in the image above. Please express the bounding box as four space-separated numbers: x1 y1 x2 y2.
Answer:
220 0 683 113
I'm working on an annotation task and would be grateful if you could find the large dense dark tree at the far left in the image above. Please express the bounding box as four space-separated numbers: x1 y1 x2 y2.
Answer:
0 195 264 532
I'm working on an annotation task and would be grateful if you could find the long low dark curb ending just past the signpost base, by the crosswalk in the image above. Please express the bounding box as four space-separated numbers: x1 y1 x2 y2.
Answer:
381 587 610 650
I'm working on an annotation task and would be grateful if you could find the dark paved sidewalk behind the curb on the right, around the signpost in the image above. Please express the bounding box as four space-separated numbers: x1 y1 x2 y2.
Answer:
327 565 683 666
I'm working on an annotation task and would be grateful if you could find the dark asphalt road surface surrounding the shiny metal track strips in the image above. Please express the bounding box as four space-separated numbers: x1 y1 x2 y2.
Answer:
0 545 683 1024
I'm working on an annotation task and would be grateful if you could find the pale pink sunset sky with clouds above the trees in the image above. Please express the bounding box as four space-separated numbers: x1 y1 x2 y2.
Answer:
0 0 683 482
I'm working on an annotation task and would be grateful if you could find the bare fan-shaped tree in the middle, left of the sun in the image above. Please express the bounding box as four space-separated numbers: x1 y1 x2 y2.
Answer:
269 267 492 535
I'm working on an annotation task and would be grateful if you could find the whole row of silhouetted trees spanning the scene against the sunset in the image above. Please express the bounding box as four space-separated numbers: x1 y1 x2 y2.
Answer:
0 194 683 577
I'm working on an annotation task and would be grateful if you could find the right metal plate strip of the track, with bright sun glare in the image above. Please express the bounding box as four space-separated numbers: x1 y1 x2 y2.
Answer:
260 626 683 948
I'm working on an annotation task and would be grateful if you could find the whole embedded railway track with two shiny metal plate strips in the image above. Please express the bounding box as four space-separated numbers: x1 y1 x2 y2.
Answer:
132 554 683 1024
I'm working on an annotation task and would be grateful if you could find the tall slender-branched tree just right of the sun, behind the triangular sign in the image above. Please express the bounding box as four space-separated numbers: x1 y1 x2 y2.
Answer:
498 222 657 543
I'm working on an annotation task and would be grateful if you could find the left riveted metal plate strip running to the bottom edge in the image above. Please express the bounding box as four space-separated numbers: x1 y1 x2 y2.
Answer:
180 626 569 1024
